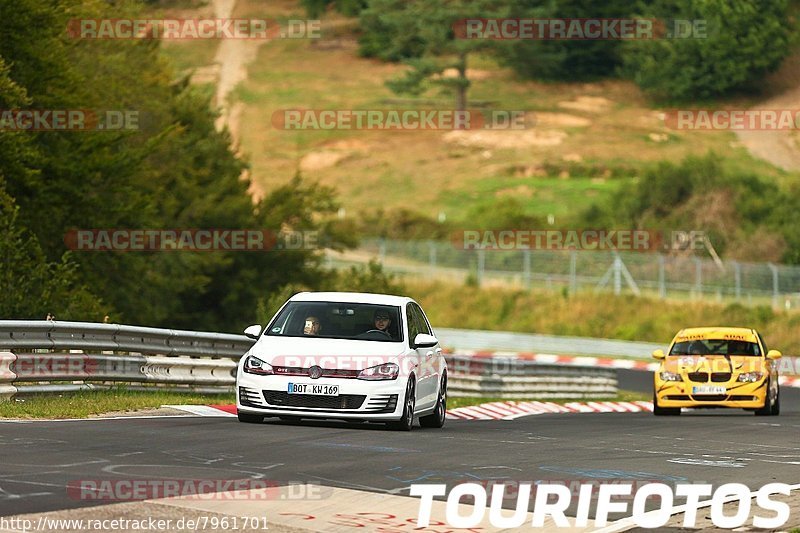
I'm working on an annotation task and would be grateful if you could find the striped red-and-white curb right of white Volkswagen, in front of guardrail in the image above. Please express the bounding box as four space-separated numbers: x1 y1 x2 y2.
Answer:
447 401 653 420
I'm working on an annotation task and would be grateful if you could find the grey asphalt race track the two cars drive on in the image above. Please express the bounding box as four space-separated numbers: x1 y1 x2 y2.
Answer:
0 371 800 516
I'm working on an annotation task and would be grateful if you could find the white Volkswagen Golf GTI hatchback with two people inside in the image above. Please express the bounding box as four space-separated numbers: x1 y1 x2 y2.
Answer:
236 292 447 431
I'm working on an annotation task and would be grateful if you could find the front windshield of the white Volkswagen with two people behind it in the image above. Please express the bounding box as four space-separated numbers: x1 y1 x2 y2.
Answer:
264 302 403 342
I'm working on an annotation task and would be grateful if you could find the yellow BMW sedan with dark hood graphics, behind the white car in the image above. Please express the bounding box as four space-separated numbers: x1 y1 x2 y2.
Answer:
653 327 781 416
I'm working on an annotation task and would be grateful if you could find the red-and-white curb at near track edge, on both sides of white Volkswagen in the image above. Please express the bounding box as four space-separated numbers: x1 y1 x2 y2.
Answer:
164 401 653 420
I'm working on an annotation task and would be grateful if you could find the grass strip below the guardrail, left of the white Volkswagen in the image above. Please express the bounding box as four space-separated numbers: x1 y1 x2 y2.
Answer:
0 388 235 418
